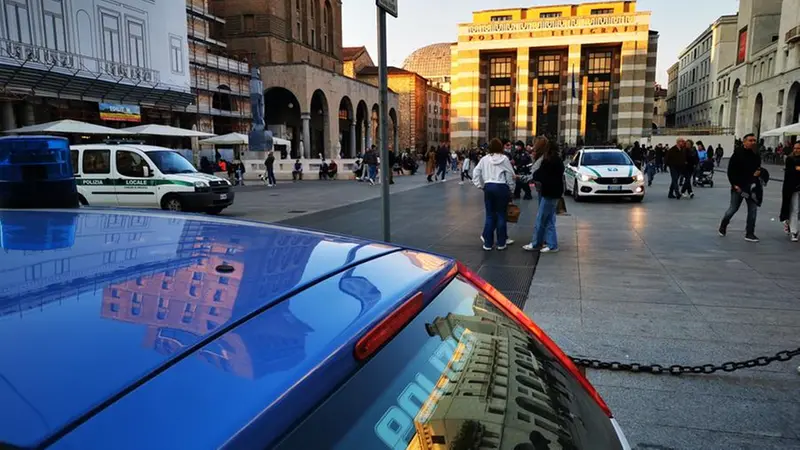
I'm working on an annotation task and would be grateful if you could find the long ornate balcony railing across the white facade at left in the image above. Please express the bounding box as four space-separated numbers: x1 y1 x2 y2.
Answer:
0 38 159 85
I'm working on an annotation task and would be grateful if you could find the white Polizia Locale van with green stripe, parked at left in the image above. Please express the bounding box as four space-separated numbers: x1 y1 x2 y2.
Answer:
70 143 234 214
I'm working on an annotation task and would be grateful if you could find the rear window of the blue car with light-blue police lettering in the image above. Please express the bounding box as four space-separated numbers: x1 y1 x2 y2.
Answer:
278 277 622 450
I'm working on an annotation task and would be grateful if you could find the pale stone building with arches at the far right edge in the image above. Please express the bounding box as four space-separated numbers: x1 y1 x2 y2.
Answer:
716 0 800 140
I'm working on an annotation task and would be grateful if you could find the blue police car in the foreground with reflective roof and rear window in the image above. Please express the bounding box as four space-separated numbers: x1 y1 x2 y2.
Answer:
0 209 630 450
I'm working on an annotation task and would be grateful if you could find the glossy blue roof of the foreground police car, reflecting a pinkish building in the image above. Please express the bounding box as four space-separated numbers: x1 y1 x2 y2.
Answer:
0 209 452 448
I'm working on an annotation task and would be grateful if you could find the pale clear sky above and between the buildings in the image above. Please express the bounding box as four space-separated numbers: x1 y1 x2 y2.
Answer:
342 0 739 87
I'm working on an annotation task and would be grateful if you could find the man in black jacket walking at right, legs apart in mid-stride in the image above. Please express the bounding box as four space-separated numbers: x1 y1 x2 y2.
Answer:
719 134 761 242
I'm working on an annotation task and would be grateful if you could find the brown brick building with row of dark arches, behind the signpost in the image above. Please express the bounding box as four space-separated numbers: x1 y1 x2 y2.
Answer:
213 0 397 159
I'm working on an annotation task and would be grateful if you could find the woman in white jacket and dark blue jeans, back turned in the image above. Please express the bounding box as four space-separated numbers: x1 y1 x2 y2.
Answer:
472 138 516 251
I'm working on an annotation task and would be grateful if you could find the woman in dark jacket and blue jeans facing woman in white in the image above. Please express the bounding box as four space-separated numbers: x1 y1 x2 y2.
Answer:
521 143 564 253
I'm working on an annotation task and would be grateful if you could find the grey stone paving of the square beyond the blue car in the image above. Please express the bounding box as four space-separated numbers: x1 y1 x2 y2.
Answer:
233 173 800 450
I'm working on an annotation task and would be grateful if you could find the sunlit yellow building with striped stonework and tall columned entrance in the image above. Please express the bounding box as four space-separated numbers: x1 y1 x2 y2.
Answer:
451 1 658 147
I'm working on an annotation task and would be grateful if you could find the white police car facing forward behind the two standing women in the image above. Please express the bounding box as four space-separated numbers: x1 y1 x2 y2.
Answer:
564 148 645 202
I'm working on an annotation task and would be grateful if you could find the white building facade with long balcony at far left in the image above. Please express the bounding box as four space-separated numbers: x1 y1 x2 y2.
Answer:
0 0 194 130
